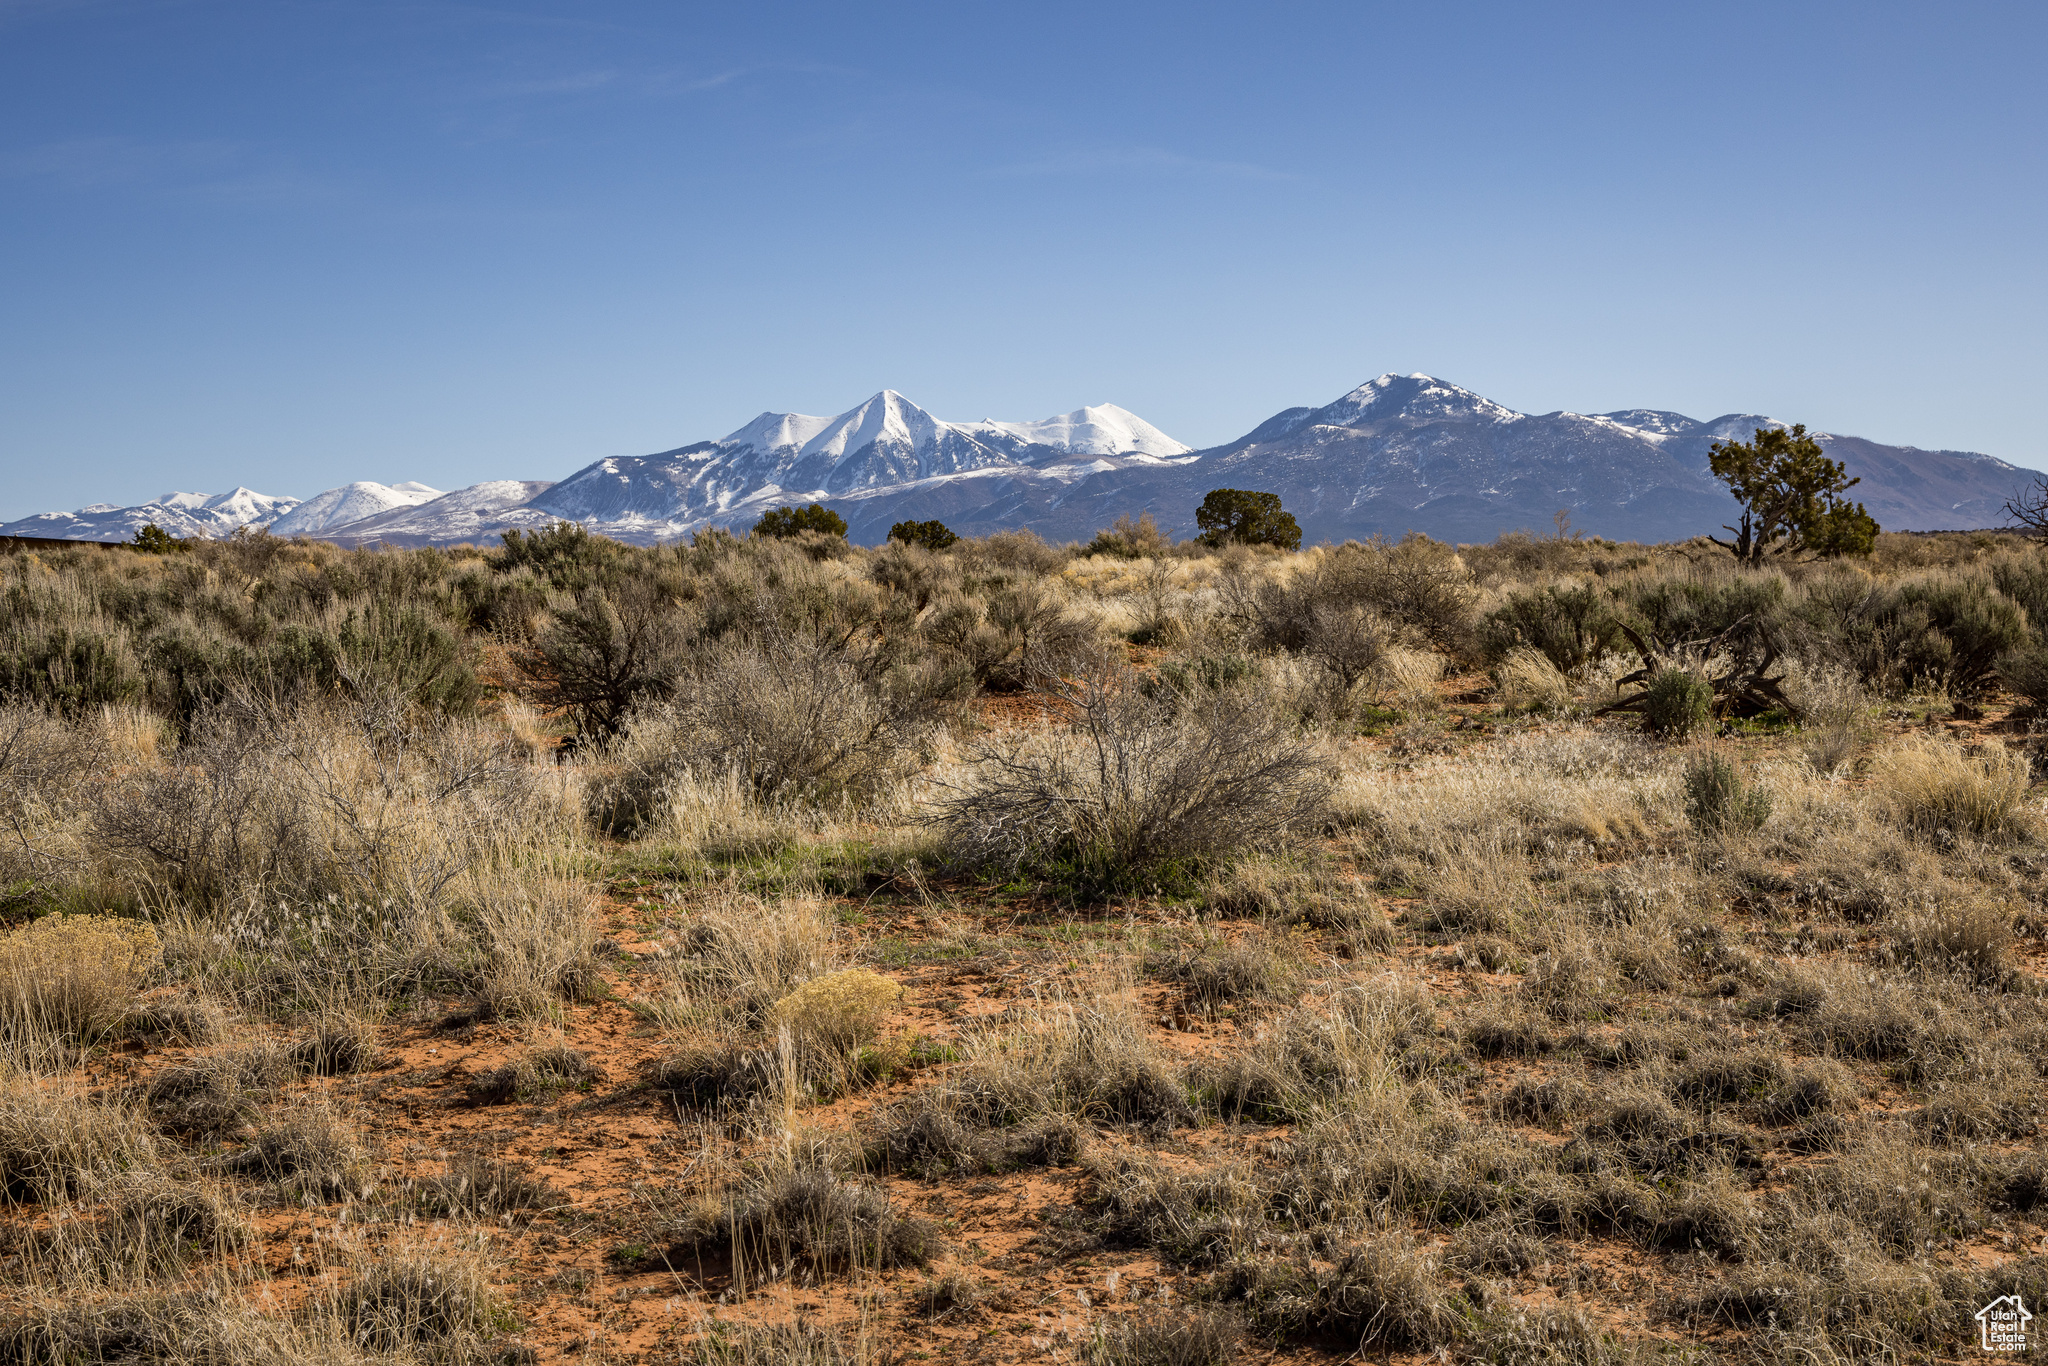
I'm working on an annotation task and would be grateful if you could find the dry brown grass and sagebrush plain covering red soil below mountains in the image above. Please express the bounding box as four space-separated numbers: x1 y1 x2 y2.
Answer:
0 518 2048 1366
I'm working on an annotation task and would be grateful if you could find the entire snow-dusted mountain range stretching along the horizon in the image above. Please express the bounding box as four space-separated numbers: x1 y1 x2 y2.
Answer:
12 375 2034 545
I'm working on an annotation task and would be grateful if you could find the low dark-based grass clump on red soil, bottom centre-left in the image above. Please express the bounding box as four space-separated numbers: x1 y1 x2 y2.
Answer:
666 1165 942 1278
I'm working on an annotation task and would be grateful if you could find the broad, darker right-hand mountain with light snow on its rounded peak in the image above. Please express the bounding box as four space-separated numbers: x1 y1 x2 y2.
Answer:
778 375 2032 543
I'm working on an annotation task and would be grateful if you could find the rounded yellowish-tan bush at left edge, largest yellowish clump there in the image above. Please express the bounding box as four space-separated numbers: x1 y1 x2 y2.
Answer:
0 913 160 1063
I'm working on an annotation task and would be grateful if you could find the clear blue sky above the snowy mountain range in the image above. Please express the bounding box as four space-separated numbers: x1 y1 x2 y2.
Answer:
0 0 2048 518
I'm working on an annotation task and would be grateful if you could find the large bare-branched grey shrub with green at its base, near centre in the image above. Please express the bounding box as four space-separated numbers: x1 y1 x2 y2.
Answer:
934 672 1331 895
